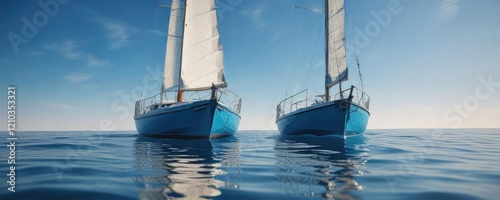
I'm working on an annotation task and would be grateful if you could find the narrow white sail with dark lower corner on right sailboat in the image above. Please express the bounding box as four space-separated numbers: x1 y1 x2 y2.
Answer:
326 0 347 87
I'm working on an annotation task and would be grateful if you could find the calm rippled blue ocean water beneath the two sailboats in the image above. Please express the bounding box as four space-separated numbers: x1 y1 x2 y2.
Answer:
0 129 500 200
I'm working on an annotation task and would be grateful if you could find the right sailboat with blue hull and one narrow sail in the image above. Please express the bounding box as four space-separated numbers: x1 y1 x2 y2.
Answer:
276 0 370 136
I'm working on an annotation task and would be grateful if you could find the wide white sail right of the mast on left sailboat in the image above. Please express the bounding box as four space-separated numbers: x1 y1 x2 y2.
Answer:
181 0 225 90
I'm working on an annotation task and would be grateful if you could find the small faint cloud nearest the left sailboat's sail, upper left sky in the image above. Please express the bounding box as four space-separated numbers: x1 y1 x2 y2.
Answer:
98 16 137 50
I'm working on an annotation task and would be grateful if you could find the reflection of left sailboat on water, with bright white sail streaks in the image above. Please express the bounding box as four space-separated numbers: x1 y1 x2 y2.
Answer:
134 137 240 199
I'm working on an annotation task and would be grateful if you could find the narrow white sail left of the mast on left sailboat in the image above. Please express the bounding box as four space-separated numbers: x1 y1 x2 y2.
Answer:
162 0 184 91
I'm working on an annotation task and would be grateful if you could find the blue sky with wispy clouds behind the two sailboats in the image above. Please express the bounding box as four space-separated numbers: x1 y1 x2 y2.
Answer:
0 0 500 130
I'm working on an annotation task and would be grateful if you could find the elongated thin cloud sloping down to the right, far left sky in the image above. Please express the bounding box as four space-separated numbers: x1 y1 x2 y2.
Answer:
45 40 113 67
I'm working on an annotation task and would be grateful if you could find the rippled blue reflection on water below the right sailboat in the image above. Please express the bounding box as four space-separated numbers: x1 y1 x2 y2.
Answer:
275 134 370 199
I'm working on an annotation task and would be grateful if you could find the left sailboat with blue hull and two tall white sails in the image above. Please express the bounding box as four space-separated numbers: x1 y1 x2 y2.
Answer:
134 0 241 138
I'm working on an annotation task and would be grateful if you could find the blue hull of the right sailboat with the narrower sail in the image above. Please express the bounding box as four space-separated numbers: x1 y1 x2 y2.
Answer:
276 100 370 136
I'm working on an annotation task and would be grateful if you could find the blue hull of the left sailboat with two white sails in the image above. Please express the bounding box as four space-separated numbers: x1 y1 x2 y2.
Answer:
134 100 240 138
